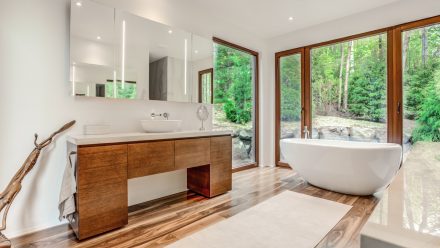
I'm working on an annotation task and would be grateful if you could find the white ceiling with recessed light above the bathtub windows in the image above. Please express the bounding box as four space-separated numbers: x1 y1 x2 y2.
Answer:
189 0 402 39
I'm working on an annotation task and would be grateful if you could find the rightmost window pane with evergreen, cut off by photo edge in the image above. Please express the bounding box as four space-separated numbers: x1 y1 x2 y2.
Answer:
402 24 440 155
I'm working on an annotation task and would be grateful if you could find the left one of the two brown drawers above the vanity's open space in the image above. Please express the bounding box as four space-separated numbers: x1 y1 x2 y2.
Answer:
128 141 174 178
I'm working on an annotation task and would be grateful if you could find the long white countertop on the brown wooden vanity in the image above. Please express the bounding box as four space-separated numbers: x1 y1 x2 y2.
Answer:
67 130 232 145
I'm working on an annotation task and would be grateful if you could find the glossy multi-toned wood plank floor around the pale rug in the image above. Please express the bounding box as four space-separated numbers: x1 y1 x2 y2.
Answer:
13 168 379 248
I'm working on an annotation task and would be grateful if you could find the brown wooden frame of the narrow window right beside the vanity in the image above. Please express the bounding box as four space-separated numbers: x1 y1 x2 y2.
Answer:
212 37 260 172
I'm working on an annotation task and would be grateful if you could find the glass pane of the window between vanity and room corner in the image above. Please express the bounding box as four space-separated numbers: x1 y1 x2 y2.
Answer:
213 43 257 168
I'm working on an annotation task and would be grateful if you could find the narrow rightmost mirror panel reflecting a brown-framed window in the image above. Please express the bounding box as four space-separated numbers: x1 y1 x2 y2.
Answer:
191 35 214 104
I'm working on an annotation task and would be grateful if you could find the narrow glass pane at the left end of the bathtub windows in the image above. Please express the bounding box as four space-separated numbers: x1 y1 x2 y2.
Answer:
277 53 302 162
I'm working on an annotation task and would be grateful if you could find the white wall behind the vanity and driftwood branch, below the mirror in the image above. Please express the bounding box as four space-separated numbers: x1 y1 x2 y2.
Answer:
0 0 217 237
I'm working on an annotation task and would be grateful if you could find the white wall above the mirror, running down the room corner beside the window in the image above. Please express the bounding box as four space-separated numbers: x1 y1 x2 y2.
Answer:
93 0 274 166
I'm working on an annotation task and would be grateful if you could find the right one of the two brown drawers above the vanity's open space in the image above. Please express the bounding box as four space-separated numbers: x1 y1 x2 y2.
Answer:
175 138 211 169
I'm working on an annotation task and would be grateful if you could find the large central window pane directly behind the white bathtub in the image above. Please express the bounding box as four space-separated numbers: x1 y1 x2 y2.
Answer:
310 33 387 142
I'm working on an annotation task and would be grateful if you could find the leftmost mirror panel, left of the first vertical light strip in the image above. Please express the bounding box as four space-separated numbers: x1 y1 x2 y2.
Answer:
70 1 114 97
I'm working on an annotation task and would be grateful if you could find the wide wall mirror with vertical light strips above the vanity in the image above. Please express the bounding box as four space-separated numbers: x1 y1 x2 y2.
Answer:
70 0 213 103
